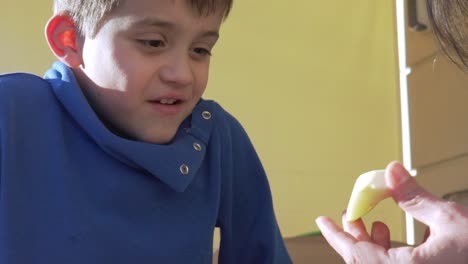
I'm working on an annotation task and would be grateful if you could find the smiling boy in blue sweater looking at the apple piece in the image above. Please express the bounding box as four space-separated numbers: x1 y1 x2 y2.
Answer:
0 0 291 264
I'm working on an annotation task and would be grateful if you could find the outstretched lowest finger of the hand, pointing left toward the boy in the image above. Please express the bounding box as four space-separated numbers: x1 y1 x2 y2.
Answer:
315 216 357 258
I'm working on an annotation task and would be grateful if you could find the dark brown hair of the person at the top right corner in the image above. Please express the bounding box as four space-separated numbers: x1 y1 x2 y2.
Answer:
427 0 468 69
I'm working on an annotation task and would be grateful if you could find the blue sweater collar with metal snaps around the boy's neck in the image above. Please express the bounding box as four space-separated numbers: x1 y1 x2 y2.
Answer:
44 62 213 192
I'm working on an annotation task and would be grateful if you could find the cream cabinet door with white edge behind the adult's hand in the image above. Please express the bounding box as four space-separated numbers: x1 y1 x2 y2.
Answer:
396 0 468 244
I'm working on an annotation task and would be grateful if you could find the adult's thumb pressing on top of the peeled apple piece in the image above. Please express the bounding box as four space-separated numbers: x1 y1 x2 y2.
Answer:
385 162 446 226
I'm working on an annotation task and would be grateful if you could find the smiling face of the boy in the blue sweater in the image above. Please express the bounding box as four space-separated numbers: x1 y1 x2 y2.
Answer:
74 0 223 144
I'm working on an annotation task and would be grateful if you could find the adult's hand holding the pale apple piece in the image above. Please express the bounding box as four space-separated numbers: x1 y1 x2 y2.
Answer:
316 162 468 264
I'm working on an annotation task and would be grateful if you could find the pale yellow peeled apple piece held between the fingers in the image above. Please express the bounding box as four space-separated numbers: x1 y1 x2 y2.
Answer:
346 170 391 222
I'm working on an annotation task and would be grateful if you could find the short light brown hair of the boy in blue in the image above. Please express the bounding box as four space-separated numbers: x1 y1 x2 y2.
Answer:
54 0 233 36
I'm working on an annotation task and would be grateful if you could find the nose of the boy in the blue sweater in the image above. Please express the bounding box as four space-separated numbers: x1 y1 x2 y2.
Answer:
159 56 194 88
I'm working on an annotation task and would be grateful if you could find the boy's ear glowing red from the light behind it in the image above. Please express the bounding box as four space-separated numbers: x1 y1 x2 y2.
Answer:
46 15 82 68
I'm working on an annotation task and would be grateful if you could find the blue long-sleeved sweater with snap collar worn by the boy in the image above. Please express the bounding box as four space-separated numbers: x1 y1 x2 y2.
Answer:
0 63 291 264
